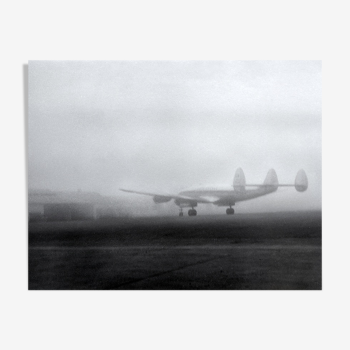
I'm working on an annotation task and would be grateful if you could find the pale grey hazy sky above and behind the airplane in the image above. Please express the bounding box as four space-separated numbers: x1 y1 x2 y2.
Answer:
28 61 322 212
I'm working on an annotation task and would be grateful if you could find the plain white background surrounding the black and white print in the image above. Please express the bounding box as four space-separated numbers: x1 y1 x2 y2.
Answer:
0 0 350 349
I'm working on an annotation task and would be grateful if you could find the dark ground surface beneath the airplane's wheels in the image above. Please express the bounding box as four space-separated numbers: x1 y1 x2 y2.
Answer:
28 212 322 290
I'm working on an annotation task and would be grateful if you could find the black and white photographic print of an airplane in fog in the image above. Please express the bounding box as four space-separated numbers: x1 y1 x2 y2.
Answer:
27 60 322 290
